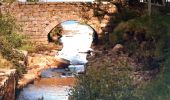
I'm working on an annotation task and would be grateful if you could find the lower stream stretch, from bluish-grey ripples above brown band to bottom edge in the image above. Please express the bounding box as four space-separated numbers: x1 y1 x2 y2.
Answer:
17 69 75 100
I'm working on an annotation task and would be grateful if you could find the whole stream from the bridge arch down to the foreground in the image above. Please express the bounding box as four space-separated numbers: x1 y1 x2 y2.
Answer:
17 21 93 100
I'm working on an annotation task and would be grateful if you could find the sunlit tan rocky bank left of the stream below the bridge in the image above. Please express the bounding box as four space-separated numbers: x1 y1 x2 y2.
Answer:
17 50 69 88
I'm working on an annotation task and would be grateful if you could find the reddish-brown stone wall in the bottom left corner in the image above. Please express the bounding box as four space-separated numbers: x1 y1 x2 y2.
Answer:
0 69 18 100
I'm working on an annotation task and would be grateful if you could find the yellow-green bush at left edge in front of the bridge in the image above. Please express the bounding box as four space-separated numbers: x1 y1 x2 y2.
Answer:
0 14 26 73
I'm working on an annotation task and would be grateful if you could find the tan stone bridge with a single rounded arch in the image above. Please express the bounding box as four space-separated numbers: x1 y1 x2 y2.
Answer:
1 2 117 44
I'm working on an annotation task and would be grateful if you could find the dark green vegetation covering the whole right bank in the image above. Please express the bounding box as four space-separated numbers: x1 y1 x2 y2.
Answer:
70 3 170 100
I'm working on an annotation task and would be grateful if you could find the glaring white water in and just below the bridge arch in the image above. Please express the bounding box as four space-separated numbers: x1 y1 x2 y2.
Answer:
56 22 93 72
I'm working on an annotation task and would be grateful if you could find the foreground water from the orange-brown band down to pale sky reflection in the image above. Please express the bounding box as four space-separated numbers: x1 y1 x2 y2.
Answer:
17 78 74 100
